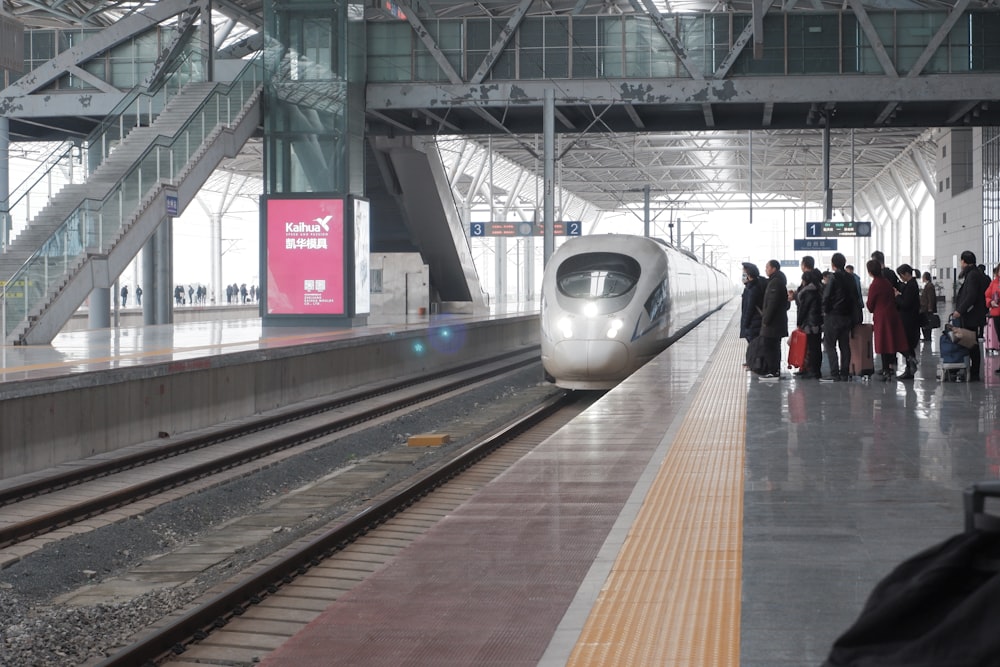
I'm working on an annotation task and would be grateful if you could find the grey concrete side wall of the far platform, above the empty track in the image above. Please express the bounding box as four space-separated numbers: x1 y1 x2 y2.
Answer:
0 315 539 478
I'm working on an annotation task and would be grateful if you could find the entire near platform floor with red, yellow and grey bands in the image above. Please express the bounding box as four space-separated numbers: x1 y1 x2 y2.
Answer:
248 305 1000 667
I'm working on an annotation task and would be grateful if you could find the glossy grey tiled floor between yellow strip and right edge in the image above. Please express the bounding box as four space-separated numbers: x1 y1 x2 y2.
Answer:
741 341 1000 667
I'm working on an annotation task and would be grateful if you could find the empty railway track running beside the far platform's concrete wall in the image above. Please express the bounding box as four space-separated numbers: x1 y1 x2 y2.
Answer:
0 348 538 565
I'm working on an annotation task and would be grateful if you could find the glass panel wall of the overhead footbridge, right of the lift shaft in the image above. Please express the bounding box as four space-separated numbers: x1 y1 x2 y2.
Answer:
368 11 1000 82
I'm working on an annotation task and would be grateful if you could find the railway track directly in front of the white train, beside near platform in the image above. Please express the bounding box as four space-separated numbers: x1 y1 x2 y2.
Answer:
100 393 595 667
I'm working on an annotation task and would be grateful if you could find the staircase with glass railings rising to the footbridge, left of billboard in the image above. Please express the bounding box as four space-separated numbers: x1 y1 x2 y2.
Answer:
0 58 261 345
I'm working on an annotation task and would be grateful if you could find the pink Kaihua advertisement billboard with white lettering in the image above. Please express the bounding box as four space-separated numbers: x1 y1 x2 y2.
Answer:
267 199 347 315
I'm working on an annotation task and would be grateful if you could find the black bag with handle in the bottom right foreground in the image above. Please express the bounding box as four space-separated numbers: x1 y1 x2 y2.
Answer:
823 482 1000 667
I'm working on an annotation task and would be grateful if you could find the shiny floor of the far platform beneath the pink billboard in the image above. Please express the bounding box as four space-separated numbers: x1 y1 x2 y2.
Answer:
0 303 538 384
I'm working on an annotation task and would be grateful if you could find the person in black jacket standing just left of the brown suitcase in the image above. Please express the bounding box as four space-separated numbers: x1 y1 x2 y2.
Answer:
820 252 861 382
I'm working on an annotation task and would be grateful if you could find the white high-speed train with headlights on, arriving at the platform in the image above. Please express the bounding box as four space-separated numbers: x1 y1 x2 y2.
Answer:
541 234 736 389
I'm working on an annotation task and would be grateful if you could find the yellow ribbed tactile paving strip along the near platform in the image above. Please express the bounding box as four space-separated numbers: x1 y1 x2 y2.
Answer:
567 336 746 667
